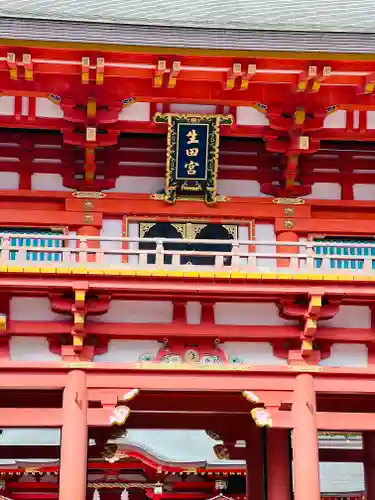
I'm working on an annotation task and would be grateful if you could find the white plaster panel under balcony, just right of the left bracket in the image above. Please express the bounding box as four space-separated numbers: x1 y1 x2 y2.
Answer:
90 300 173 323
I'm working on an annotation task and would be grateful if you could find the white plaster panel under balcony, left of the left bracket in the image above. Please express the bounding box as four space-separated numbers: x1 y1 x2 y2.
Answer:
10 297 68 321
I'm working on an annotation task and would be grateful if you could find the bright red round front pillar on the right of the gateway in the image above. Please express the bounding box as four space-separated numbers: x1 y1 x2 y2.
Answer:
292 373 320 500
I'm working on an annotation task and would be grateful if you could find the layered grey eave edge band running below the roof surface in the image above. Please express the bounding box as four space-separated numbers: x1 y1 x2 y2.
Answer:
0 17 375 54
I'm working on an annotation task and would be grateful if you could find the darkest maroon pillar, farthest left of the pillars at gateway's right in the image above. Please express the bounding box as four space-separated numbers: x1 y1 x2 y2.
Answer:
246 427 264 500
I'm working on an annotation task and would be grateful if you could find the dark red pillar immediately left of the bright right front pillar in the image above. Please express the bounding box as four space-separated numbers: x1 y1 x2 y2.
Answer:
267 429 291 500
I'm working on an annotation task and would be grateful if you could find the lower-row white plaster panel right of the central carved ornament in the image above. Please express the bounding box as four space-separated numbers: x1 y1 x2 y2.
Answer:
220 342 287 366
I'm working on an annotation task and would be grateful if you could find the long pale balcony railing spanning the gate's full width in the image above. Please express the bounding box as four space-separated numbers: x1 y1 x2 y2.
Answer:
0 233 375 275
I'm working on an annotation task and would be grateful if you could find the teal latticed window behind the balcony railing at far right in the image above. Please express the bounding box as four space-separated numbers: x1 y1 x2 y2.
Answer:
314 236 375 270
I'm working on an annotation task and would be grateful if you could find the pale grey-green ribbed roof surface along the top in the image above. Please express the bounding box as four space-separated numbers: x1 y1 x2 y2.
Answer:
0 0 375 33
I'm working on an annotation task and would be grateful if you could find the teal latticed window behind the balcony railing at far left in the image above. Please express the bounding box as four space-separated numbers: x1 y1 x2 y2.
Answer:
0 228 64 262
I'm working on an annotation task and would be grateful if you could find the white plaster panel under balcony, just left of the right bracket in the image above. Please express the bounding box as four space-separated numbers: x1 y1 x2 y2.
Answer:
215 302 293 325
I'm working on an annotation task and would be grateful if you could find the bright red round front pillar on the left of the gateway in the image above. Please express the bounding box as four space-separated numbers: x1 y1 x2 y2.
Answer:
59 370 88 500
